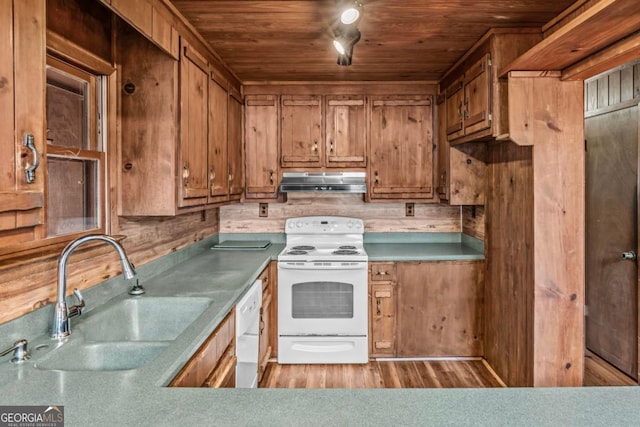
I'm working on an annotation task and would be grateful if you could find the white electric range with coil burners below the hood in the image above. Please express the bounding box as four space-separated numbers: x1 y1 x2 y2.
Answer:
278 216 369 363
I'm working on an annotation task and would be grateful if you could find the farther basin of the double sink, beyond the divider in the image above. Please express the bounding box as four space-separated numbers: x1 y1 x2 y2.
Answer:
74 297 211 342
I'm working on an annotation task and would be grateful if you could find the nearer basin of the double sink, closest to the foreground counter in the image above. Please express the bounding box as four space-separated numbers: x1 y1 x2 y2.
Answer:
35 342 169 371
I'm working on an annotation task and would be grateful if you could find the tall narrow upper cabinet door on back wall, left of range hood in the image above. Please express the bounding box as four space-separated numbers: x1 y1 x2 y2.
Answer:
244 95 278 199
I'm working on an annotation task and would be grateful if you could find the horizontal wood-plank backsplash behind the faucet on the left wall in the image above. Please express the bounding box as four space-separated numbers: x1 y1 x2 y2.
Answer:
0 209 218 323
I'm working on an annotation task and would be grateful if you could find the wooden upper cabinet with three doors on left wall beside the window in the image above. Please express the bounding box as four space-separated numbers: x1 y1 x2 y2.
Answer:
117 31 243 216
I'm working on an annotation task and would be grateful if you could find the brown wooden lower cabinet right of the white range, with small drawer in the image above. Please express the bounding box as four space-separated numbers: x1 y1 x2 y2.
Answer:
369 261 484 357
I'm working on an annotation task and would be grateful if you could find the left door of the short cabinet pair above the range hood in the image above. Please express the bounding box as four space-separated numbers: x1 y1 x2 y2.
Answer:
280 95 323 167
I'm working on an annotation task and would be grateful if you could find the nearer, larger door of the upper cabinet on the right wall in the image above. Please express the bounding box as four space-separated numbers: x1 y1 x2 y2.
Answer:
464 54 491 135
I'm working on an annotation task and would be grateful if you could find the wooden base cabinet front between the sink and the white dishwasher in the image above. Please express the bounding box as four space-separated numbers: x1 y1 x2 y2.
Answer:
169 310 235 387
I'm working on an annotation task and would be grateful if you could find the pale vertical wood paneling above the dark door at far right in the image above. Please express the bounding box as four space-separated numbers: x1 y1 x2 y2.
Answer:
584 59 640 117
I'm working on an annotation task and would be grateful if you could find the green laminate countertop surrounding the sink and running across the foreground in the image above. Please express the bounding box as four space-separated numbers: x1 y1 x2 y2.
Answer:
0 236 640 426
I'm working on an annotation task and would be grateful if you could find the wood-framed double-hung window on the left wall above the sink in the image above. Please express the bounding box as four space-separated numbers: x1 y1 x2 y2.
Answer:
46 57 105 237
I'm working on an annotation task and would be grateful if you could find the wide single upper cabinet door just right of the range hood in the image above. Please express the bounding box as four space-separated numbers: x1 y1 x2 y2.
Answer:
369 96 433 199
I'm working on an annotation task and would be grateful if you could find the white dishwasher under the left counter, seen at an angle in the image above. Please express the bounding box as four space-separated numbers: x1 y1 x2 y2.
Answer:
236 280 262 388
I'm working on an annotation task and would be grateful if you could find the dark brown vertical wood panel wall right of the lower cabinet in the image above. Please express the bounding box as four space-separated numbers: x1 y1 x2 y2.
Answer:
485 143 534 386
